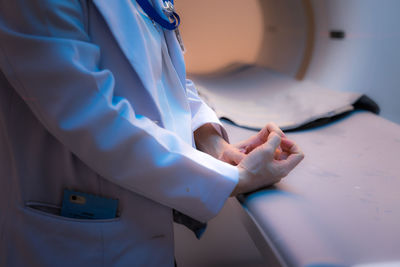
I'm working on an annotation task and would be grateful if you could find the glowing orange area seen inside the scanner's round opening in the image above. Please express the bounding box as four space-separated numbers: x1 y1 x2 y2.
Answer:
176 0 263 73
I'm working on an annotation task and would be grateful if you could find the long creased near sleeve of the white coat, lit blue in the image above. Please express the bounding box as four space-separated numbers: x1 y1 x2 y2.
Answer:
0 0 238 222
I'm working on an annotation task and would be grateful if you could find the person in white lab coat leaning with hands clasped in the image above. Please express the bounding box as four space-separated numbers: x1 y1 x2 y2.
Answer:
0 0 303 266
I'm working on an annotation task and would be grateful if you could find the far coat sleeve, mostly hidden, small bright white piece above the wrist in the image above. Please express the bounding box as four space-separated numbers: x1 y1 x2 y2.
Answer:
186 79 229 142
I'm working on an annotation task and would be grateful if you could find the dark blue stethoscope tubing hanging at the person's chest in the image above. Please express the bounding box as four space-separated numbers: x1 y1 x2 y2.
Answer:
136 0 181 30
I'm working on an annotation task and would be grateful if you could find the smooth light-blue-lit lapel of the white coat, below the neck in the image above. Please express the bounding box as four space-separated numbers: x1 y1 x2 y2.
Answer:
93 0 161 94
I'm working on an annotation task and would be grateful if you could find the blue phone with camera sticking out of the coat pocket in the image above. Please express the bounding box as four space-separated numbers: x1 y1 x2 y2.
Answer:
61 189 118 220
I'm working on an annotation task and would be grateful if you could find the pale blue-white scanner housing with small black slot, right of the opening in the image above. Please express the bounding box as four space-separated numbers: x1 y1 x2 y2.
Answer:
306 0 400 124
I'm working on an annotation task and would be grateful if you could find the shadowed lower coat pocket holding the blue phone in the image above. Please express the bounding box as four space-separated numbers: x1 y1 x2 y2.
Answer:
19 202 120 266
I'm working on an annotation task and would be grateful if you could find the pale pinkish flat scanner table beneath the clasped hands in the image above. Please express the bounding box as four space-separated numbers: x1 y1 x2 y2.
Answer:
224 111 400 266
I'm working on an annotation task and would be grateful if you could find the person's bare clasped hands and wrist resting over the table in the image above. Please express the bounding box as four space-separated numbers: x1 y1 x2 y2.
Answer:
195 123 304 196
